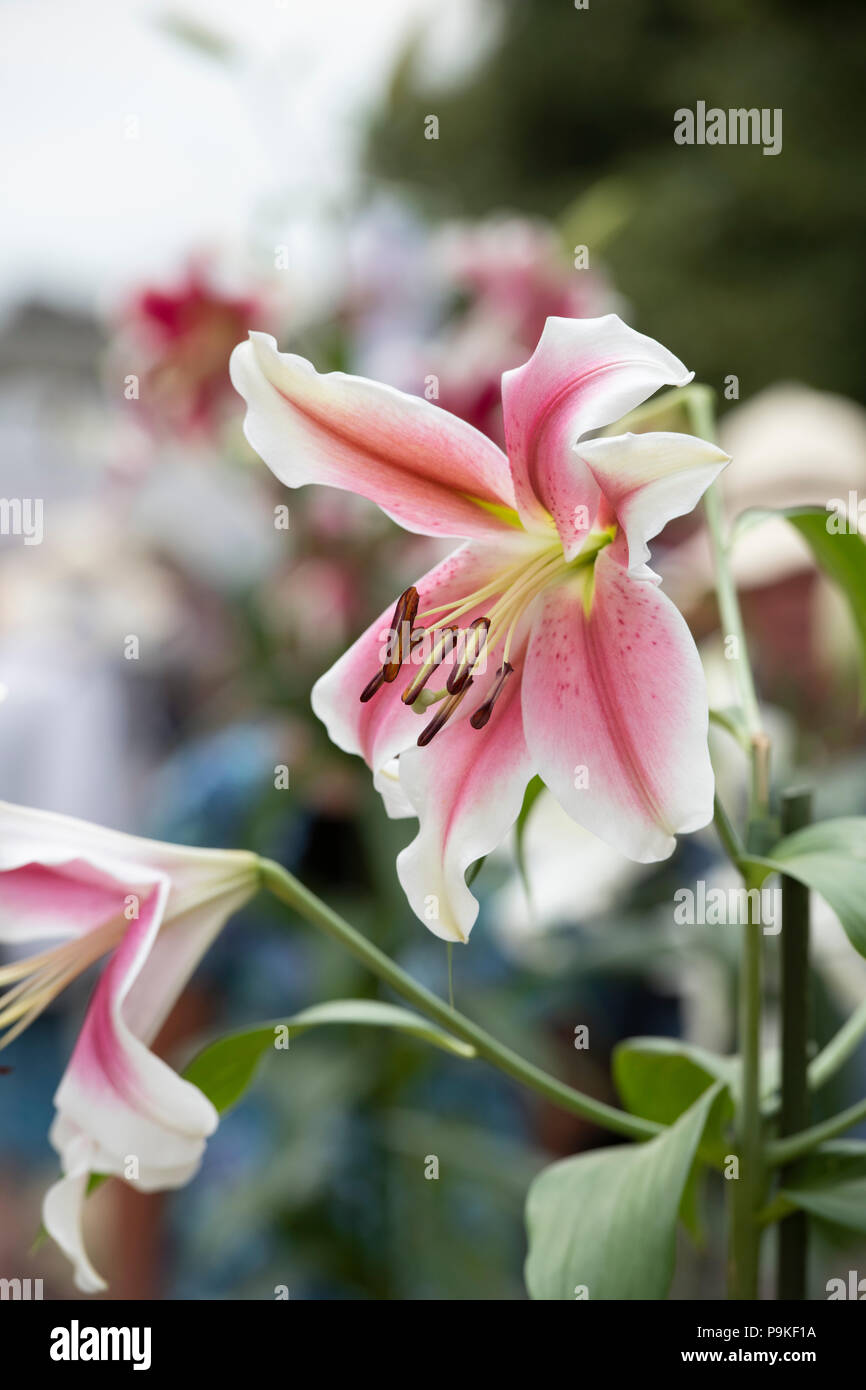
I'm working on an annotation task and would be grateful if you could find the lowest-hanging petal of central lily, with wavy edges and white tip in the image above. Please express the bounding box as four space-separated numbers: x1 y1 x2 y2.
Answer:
398 656 534 941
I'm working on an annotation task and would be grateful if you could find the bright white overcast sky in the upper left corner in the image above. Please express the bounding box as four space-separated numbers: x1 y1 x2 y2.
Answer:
0 0 487 318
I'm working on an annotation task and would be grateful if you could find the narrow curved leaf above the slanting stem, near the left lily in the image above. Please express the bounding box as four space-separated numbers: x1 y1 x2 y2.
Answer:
183 999 475 1112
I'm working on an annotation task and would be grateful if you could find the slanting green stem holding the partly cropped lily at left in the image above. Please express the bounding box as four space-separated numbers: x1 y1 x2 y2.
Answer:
260 859 663 1140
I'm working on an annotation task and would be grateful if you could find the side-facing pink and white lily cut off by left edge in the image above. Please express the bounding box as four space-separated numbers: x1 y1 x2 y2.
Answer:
0 802 259 1293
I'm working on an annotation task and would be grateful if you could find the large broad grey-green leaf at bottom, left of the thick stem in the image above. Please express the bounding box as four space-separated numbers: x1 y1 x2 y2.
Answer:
525 1081 721 1300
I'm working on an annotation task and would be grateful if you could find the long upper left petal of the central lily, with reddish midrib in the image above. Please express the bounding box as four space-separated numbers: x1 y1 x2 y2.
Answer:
231 334 514 538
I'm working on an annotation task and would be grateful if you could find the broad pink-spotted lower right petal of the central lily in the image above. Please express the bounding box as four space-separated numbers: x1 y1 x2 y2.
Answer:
523 550 713 863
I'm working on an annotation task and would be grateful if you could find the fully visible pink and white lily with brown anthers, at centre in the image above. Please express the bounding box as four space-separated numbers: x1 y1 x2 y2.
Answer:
232 314 728 941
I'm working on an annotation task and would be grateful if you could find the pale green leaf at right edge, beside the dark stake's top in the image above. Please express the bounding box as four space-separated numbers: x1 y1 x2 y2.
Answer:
748 816 866 956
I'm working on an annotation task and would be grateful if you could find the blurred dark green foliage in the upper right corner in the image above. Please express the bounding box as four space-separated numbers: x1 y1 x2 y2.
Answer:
368 0 866 400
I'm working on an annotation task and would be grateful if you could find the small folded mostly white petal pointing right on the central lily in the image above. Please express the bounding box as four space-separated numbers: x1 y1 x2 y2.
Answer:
575 431 731 578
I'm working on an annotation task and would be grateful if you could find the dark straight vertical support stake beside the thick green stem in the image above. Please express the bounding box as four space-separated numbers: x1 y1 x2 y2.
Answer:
776 791 812 1300
